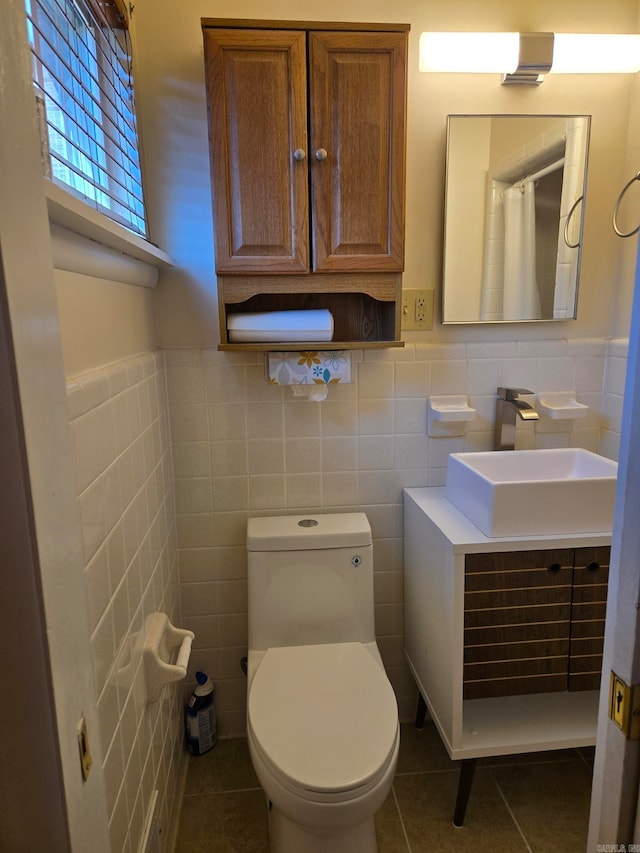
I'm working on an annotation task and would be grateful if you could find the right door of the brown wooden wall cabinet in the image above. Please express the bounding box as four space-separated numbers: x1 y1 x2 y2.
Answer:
309 32 407 272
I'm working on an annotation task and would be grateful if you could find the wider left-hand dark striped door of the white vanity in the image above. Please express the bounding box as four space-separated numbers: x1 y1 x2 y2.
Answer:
463 548 573 699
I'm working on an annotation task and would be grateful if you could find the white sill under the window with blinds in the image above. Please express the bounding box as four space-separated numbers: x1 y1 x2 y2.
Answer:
43 178 174 269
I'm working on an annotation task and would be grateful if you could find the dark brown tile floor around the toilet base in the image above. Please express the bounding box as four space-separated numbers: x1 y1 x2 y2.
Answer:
175 723 593 853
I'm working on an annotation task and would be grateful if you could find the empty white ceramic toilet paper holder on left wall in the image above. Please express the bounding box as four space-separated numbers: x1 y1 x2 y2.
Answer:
142 613 195 703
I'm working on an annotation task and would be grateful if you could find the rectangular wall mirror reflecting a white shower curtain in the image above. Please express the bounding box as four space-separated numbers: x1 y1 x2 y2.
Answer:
442 115 590 323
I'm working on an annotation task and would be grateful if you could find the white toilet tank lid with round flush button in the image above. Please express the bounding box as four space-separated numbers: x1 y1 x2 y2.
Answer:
247 512 371 551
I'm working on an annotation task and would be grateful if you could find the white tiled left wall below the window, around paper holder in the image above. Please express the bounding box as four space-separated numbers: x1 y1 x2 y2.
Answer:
67 353 180 853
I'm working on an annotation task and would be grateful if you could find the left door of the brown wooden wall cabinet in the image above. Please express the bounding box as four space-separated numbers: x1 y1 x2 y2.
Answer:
204 29 309 273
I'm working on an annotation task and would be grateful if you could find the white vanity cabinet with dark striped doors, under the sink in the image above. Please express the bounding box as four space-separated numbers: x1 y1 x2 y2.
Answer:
404 488 611 760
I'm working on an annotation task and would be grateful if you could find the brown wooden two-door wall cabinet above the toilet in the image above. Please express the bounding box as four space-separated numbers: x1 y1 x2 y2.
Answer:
202 19 409 349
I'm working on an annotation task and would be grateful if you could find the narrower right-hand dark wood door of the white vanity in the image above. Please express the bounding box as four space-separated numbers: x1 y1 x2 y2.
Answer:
569 547 611 690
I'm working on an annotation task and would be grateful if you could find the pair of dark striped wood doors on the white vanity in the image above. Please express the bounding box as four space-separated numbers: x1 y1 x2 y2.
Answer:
463 547 609 699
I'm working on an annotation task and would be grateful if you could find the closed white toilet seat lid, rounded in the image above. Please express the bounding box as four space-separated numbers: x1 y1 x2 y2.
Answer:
248 643 398 799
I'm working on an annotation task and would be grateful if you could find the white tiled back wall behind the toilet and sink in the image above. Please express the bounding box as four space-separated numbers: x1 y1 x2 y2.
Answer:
165 339 623 735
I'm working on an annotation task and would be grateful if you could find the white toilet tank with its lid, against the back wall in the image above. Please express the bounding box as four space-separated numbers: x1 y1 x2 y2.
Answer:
247 512 375 650
